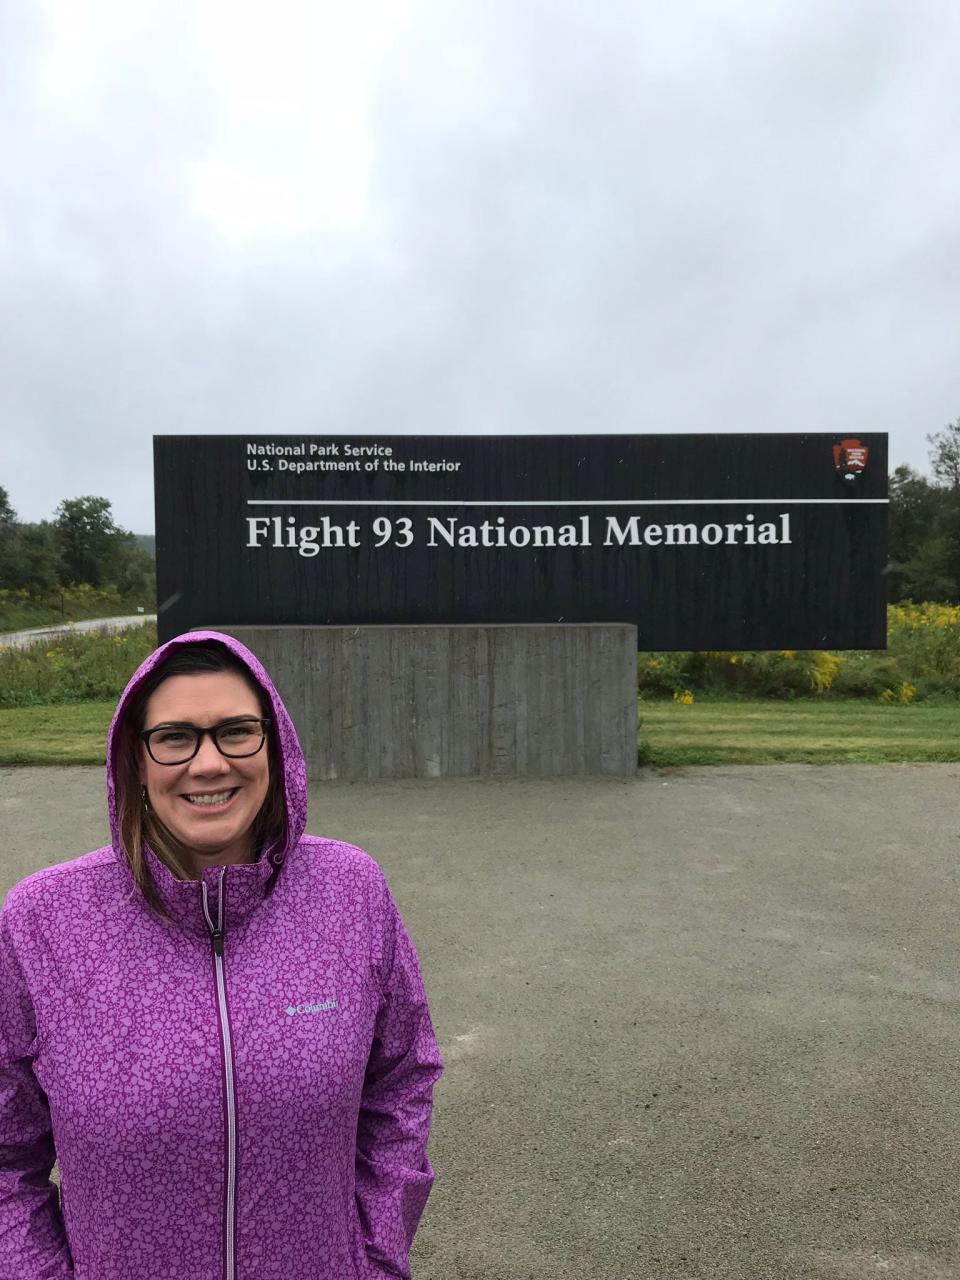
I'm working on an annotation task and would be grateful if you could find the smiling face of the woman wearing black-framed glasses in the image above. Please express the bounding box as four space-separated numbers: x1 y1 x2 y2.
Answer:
140 671 270 877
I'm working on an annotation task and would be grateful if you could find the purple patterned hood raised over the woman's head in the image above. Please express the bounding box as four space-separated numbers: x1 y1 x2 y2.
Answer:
106 631 307 867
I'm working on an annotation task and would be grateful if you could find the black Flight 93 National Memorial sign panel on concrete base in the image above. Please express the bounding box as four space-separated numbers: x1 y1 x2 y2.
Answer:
154 433 887 649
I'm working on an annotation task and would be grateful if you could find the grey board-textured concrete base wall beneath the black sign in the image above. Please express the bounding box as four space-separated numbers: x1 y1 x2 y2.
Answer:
211 623 636 780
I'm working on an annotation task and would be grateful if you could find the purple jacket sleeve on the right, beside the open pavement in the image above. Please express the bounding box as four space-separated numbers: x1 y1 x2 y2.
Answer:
356 879 443 1280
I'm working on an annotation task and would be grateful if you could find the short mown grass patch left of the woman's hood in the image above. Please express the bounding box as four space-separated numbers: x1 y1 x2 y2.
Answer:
0 701 116 764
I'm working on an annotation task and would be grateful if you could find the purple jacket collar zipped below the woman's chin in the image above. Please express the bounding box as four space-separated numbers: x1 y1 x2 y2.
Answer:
143 845 279 937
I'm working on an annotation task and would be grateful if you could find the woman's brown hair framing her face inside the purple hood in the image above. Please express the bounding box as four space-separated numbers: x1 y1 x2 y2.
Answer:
111 640 287 918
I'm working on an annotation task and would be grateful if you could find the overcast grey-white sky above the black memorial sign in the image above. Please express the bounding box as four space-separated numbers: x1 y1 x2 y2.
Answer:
0 0 960 532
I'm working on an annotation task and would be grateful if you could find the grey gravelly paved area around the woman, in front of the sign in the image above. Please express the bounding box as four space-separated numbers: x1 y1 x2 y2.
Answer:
0 764 960 1280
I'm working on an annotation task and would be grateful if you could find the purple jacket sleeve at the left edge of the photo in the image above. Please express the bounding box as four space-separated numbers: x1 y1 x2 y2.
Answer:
0 899 73 1280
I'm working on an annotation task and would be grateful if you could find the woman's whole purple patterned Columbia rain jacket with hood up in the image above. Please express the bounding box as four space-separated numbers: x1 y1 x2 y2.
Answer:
0 632 443 1280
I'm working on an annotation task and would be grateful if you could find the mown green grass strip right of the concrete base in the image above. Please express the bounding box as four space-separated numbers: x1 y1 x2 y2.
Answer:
637 699 960 768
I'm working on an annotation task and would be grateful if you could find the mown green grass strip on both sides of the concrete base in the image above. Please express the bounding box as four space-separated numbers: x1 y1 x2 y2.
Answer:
0 699 960 768
